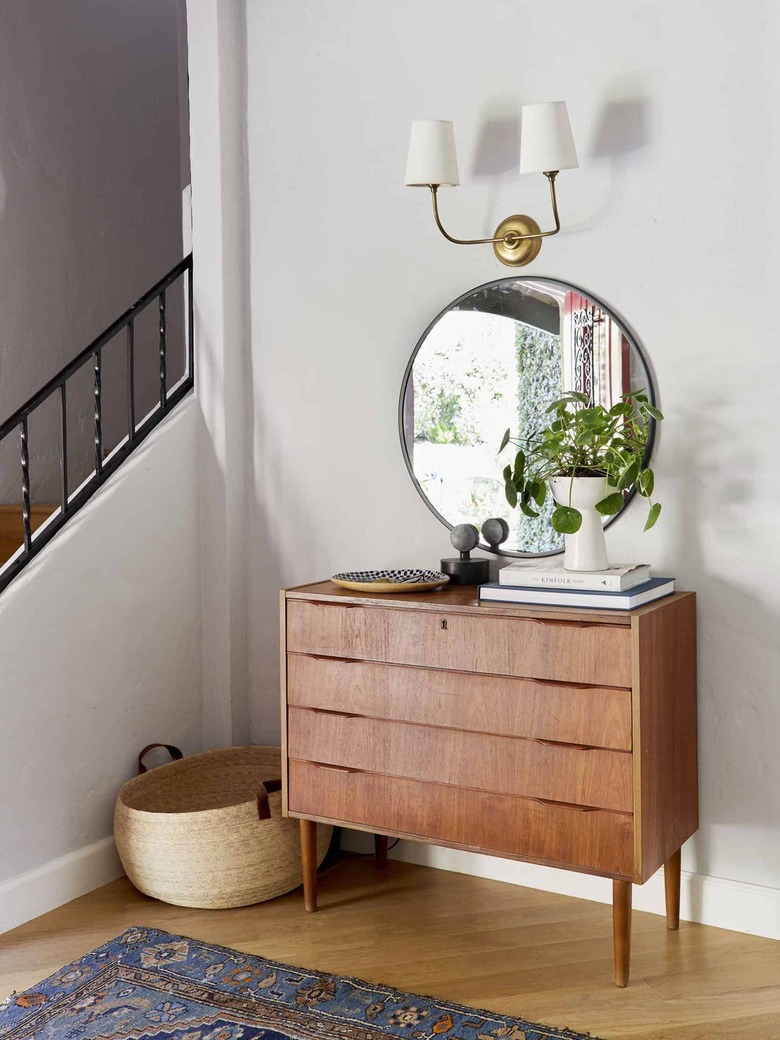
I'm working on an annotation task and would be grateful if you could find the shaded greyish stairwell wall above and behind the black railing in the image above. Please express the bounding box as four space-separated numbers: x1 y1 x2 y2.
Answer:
0 0 188 502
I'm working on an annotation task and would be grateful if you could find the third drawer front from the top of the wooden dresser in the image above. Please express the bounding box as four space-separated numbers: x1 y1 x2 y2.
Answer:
287 707 631 812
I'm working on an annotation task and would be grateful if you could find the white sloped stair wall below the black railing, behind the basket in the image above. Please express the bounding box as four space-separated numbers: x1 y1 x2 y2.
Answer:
0 397 202 932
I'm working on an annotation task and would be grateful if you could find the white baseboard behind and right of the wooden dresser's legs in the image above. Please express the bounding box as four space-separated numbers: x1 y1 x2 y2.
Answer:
342 830 780 939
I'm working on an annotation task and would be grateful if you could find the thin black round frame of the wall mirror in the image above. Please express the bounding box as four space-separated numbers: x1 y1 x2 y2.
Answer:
398 275 657 560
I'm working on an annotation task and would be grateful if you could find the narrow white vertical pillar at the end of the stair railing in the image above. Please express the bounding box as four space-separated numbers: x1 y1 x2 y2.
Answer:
187 0 254 747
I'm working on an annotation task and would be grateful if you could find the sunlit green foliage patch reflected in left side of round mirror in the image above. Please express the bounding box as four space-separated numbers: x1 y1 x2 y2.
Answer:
414 341 505 444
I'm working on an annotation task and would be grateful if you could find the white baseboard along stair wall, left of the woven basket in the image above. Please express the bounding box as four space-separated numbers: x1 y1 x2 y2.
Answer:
0 838 123 932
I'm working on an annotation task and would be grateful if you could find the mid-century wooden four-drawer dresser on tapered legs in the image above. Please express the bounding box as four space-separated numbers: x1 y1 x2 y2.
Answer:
282 581 698 986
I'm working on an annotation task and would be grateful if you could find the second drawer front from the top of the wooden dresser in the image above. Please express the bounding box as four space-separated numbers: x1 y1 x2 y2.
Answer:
287 654 631 751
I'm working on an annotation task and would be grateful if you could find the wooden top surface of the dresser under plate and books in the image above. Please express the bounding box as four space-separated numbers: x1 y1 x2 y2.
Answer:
284 581 695 625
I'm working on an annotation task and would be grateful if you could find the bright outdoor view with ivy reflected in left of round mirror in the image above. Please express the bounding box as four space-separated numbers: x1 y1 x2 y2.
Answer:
404 297 562 552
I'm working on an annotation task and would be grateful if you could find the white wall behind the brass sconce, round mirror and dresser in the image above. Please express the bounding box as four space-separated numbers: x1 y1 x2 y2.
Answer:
190 0 780 935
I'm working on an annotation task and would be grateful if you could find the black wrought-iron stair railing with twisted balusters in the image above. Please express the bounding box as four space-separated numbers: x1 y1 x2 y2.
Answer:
0 253 194 592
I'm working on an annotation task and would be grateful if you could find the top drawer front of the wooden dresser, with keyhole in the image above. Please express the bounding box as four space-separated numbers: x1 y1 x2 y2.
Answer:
287 600 631 686
